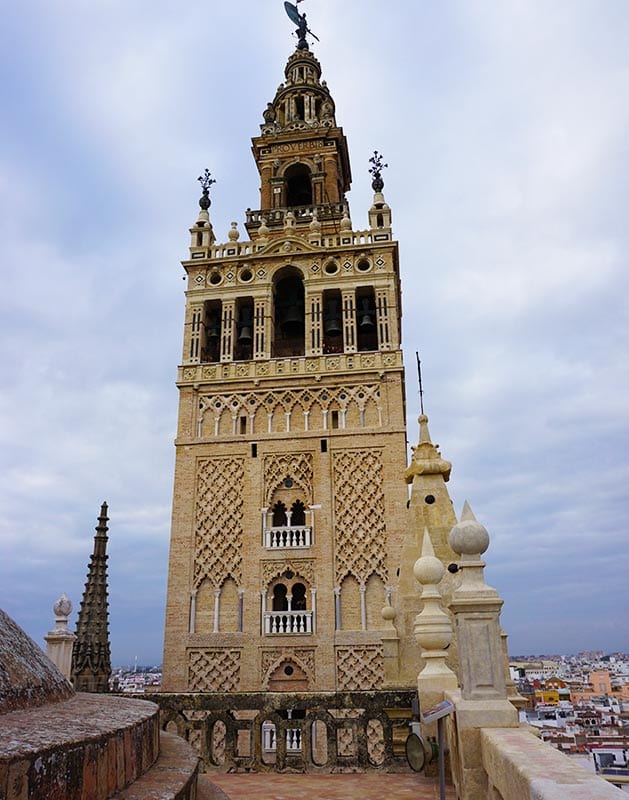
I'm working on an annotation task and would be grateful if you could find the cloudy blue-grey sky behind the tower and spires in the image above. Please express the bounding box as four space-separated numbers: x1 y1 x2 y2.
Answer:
0 0 629 664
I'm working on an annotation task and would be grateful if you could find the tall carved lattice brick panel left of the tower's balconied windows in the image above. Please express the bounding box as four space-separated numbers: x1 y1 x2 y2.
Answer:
194 458 244 589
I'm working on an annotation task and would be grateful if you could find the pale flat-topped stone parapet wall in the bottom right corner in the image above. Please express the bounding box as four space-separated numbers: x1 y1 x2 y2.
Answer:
480 728 626 800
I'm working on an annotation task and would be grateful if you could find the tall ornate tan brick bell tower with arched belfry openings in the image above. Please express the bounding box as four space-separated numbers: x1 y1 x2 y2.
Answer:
162 32 416 692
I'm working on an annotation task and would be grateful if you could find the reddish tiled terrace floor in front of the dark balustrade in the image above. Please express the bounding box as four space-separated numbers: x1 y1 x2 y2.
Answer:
199 772 454 800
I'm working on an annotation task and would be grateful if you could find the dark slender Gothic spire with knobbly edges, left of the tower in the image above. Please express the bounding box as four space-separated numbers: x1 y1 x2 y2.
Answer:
72 503 111 693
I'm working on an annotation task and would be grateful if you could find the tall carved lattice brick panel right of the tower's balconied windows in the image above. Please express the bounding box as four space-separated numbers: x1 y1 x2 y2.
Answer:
333 450 388 586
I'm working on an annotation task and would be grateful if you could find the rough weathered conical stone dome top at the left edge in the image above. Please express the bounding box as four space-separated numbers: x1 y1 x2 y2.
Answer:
0 609 73 714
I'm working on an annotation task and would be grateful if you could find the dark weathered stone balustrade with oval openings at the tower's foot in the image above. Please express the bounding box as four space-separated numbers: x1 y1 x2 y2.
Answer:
150 691 416 772
